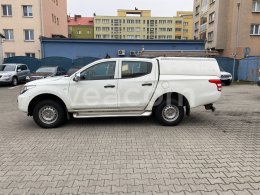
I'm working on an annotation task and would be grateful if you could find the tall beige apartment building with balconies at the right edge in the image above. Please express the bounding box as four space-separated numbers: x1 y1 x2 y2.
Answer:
193 0 260 59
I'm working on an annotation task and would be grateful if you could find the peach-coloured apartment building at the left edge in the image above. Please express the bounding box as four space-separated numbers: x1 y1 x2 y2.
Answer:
0 0 68 58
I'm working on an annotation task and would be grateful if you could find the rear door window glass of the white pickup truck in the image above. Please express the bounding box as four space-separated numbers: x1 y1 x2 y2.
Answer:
121 61 153 79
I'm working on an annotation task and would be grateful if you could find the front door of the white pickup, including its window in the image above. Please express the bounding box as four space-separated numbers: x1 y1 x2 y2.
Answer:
69 61 117 111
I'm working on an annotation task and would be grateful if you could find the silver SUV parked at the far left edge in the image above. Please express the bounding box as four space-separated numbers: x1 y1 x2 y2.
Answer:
0 64 31 86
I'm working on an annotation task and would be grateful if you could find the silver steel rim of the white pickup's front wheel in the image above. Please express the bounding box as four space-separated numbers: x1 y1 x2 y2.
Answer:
39 106 58 124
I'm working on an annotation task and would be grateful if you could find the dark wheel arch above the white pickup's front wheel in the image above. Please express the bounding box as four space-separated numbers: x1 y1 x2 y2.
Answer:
28 93 67 116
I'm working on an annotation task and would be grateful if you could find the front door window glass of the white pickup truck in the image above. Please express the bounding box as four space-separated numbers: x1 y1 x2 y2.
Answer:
80 61 116 80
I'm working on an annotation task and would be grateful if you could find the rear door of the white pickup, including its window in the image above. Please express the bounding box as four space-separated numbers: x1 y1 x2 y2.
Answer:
118 60 158 110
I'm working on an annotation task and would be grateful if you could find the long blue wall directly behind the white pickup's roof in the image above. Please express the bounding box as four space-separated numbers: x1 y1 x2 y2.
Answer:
42 39 204 59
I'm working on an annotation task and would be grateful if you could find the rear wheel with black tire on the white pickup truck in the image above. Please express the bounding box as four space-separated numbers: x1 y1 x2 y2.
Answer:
154 100 184 126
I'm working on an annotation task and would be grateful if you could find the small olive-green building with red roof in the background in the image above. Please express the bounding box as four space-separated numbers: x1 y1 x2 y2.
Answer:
68 15 94 39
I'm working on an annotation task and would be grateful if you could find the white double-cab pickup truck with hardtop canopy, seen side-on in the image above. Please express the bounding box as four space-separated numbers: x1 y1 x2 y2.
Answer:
18 57 222 128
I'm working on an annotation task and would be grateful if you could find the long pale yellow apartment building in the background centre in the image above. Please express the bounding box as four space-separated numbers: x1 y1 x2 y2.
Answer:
94 9 193 40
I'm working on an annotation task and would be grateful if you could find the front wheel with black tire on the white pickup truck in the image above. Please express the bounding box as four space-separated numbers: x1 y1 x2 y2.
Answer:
33 100 67 129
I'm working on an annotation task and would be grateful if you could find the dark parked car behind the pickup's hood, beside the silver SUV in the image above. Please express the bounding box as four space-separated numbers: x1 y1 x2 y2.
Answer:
31 66 66 81
